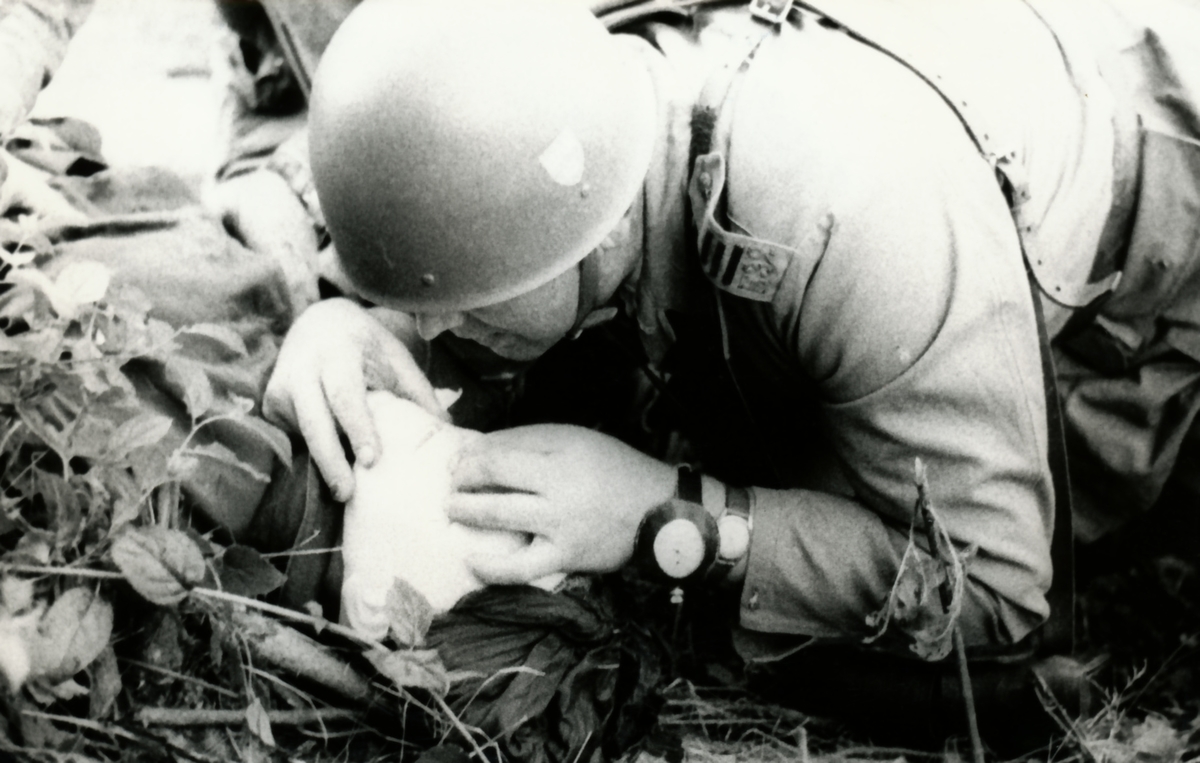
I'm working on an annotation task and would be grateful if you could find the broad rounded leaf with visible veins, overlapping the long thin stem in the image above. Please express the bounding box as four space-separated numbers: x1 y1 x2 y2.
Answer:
112 527 205 606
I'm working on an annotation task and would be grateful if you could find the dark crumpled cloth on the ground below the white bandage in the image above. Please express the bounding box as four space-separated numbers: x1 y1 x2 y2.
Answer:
427 581 666 763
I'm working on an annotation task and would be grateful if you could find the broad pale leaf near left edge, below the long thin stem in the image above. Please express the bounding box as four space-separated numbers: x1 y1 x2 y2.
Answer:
30 587 113 681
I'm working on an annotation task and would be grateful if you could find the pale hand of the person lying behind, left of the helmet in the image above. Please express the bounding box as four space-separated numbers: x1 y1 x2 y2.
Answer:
209 170 319 316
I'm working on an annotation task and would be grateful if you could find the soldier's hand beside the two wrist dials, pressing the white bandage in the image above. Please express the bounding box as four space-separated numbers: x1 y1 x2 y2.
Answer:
446 425 676 583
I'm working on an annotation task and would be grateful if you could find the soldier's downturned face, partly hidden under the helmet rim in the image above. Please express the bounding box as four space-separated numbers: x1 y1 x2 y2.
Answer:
416 266 580 360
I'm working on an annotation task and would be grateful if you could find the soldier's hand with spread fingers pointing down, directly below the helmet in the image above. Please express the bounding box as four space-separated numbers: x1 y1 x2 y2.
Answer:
263 299 446 501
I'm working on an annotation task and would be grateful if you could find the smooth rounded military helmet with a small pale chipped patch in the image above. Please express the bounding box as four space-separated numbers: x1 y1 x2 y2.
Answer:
310 0 656 312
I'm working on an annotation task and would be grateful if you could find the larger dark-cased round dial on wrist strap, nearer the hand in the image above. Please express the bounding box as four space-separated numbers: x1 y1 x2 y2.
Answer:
634 465 719 585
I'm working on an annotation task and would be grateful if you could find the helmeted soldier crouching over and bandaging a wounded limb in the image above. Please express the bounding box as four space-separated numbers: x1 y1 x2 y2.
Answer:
264 0 1200 753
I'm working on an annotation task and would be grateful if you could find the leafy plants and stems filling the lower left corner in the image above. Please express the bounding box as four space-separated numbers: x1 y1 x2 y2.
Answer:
0 245 486 761
